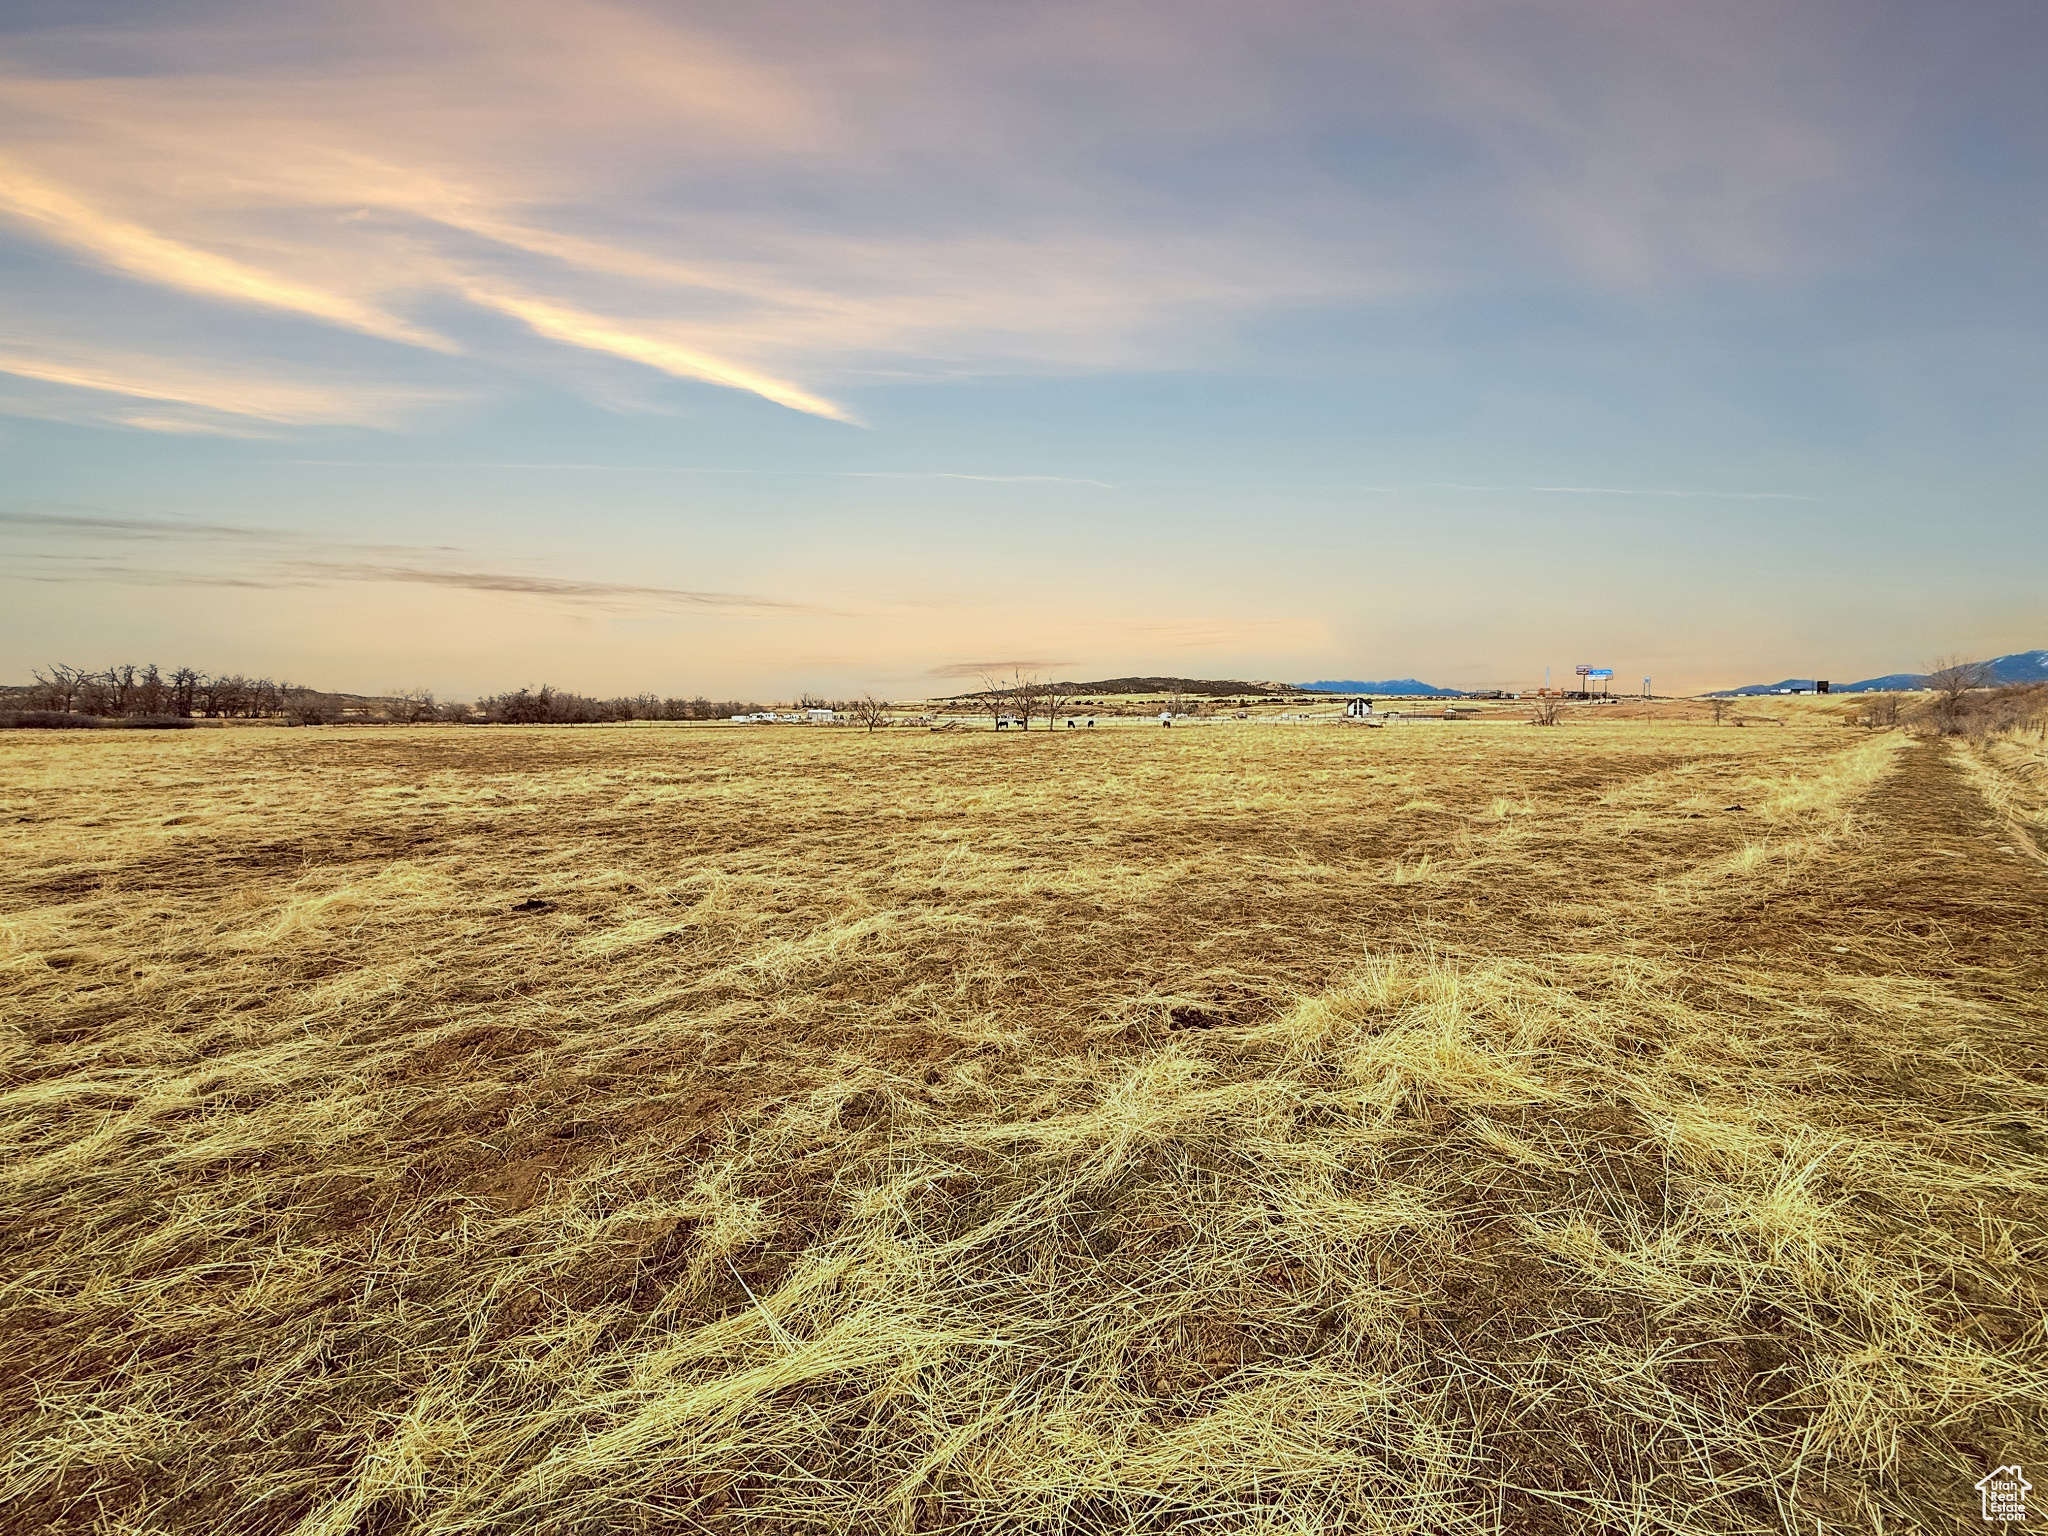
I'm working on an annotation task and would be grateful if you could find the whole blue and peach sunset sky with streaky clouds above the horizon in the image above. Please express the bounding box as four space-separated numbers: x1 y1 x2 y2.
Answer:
0 0 2048 698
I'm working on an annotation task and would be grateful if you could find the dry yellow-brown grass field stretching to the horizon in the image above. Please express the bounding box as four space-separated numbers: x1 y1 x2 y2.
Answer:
0 716 2048 1536
